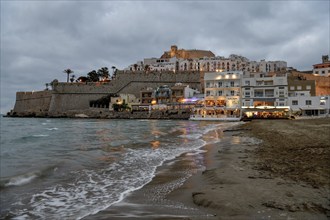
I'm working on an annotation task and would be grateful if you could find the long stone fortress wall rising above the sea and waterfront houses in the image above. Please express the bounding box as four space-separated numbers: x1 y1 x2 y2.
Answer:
12 71 202 117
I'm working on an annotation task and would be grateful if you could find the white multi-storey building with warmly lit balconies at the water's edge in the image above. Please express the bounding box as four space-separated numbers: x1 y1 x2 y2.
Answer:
194 71 243 118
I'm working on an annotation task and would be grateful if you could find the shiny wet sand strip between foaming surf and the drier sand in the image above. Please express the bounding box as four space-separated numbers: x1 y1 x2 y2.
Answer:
83 121 237 220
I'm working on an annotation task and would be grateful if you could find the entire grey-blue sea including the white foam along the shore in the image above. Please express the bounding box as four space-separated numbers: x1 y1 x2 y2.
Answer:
0 116 239 219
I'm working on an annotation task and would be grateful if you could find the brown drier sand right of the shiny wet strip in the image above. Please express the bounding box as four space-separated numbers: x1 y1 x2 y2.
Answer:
172 118 330 219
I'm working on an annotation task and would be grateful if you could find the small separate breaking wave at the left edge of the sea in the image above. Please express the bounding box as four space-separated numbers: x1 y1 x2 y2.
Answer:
0 166 57 189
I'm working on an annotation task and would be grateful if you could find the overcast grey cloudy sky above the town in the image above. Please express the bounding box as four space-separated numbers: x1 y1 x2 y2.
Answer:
0 0 330 113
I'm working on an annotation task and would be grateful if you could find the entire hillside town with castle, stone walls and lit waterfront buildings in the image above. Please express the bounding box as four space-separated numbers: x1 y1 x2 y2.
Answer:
7 45 330 121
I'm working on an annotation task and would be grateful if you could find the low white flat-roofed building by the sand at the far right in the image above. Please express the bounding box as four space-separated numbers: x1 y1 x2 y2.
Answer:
288 95 330 116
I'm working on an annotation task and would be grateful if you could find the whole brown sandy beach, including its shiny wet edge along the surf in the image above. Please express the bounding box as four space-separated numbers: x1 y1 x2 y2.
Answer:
86 118 330 220
